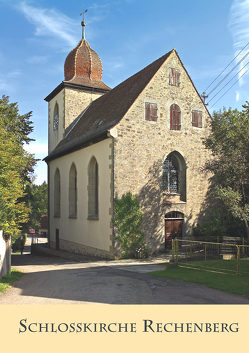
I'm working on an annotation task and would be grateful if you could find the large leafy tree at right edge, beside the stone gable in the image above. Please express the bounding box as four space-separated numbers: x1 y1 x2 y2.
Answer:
204 102 249 240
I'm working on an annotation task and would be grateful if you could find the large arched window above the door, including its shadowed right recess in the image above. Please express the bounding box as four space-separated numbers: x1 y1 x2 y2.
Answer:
162 151 187 202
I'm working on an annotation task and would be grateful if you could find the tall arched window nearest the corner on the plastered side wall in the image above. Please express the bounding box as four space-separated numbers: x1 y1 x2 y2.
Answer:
88 157 99 219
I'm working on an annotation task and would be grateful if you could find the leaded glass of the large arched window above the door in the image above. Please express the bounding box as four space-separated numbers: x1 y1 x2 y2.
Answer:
163 155 179 194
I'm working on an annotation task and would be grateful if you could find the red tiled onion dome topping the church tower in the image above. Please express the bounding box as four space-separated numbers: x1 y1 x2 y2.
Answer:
64 39 109 88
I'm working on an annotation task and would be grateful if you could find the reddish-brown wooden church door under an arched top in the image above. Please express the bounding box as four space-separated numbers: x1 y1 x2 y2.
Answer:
165 211 184 250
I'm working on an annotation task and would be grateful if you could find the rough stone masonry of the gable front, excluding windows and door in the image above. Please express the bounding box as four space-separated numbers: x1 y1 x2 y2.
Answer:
114 53 211 251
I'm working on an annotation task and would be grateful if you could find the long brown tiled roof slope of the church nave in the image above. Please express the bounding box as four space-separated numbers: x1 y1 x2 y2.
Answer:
45 50 173 162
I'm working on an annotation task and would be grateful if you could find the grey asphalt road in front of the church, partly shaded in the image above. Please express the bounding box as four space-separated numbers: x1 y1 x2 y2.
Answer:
0 252 249 304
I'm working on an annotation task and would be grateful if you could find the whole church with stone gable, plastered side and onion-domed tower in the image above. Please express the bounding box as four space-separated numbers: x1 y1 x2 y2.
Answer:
45 22 209 258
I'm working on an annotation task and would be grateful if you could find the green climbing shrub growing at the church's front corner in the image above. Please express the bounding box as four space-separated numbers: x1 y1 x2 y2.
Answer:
112 192 144 256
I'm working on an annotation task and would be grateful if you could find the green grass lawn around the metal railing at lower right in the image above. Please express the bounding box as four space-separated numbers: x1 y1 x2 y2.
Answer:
150 259 249 296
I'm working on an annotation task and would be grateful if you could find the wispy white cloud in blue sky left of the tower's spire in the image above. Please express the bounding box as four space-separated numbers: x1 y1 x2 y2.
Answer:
18 1 79 50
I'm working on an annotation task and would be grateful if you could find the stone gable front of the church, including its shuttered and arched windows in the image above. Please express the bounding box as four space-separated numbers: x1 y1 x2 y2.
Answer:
114 50 209 248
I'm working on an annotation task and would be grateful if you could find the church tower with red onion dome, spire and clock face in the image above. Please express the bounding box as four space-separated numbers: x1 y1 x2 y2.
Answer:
45 20 110 153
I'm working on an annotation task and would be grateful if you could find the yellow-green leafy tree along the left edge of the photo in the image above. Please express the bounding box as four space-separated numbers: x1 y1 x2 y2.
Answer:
0 96 36 238
